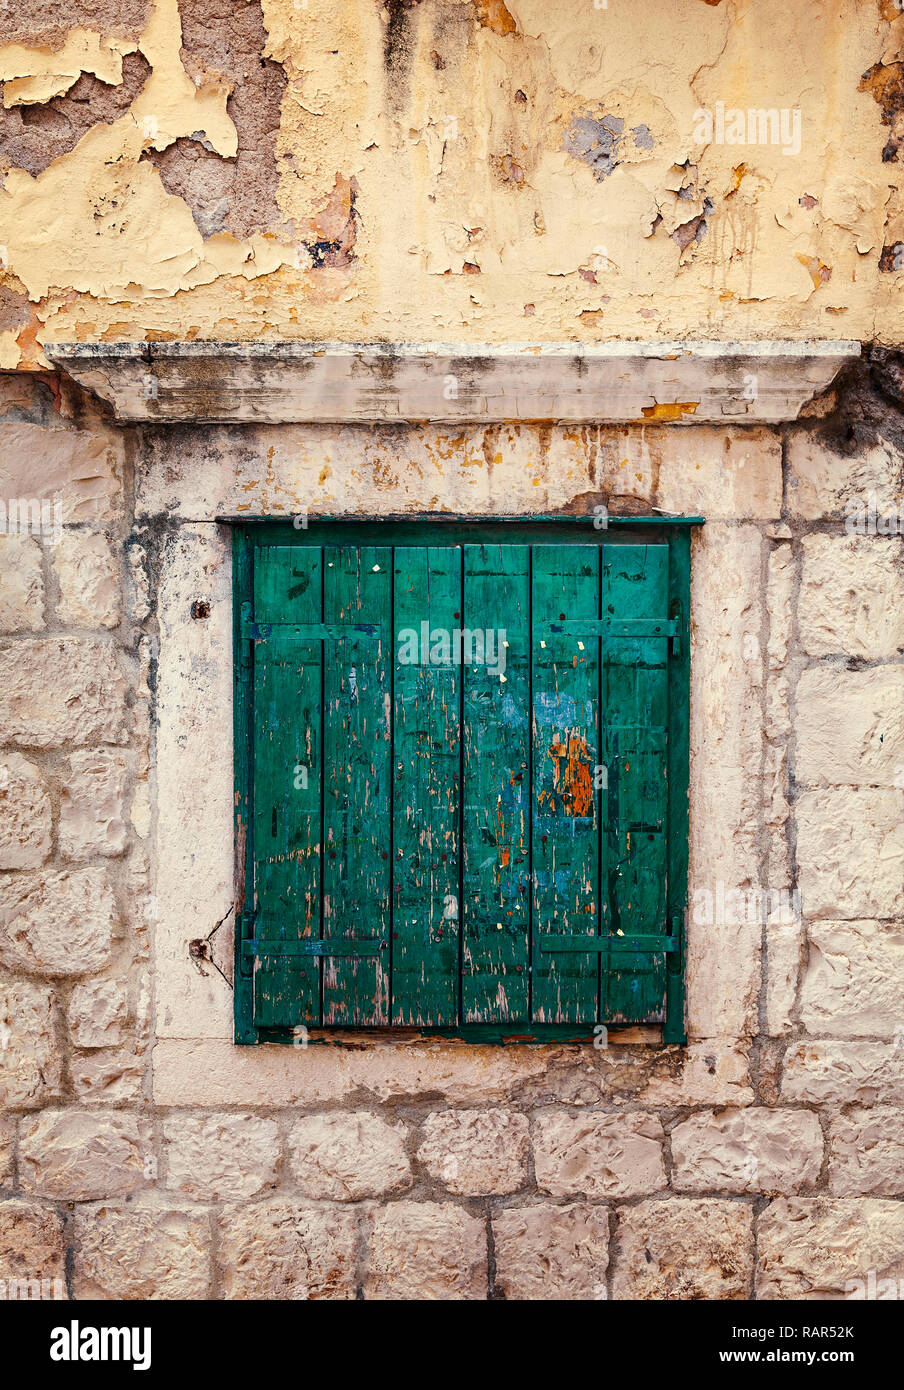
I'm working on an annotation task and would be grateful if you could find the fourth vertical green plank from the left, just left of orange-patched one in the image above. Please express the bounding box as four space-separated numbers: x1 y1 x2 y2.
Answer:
462 545 530 1023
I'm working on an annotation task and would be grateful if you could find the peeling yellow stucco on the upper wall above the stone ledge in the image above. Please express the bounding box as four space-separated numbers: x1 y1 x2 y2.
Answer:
0 0 904 368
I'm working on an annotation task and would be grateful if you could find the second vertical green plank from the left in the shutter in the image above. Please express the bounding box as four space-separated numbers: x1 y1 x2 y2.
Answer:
323 545 392 1026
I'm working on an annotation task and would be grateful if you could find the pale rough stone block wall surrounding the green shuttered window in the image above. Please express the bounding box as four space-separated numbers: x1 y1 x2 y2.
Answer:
0 367 904 1300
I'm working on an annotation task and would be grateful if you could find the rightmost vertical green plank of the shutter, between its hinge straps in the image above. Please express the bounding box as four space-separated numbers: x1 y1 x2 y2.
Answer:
602 545 669 1023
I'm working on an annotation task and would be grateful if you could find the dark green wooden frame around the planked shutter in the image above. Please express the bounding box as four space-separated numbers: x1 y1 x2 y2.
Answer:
232 516 704 1047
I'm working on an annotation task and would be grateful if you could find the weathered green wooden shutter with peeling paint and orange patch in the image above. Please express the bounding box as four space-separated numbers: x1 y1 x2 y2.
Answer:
235 527 688 1041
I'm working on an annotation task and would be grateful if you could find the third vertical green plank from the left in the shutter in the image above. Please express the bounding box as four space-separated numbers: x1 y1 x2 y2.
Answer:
392 546 462 1026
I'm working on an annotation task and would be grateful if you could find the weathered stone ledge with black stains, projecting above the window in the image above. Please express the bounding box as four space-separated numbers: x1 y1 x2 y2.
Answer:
45 341 859 424
